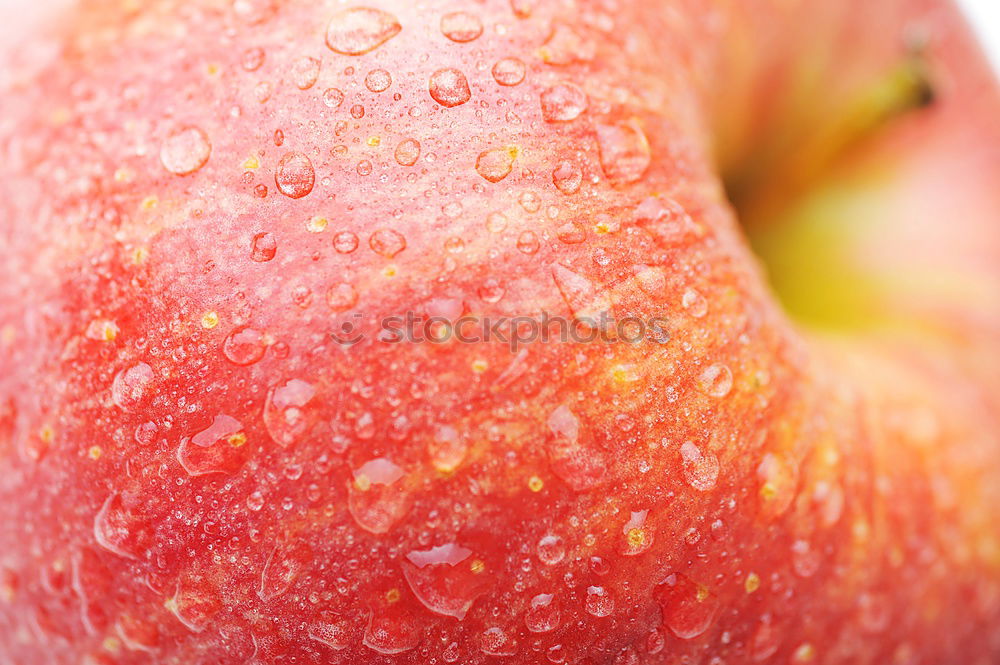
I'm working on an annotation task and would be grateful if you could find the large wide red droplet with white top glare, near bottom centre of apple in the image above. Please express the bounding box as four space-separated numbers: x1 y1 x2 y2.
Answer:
402 543 489 620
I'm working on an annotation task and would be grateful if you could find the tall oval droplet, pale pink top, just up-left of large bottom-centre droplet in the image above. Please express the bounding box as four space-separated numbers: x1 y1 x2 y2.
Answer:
348 457 410 533
